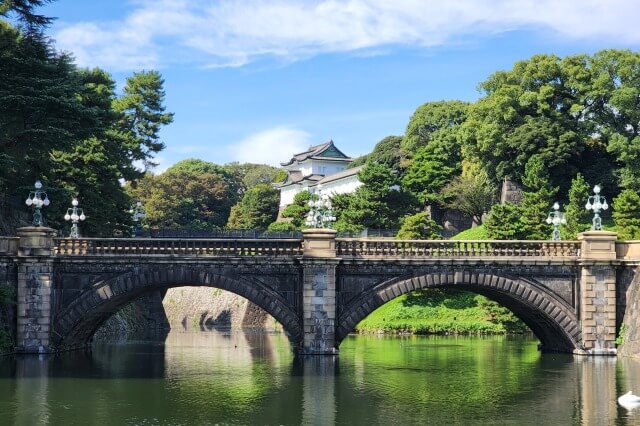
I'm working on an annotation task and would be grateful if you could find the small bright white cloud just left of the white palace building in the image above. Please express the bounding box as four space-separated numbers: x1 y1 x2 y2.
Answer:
228 126 311 166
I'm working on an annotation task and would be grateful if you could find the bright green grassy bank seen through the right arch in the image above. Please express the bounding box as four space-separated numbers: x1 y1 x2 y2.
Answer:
356 289 529 334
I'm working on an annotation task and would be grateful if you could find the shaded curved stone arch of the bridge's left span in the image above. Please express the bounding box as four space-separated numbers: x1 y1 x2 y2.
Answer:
51 265 302 348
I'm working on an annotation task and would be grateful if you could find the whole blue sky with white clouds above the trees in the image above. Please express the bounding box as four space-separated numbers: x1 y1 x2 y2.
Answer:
41 0 640 171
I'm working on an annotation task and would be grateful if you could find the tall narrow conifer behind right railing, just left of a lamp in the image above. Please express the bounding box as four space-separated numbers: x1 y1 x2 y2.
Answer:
520 155 558 240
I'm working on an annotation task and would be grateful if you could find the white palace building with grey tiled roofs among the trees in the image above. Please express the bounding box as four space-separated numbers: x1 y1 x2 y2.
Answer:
276 140 362 209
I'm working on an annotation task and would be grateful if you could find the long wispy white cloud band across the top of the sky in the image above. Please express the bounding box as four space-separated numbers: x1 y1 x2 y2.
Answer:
55 0 640 70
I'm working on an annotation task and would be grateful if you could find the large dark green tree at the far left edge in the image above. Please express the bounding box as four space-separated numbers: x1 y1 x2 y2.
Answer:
0 20 93 194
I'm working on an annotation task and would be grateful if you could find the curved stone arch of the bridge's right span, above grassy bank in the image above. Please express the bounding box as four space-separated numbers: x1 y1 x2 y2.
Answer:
336 271 581 352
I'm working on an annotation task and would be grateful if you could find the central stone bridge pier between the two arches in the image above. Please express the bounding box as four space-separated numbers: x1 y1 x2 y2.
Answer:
299 229 340 355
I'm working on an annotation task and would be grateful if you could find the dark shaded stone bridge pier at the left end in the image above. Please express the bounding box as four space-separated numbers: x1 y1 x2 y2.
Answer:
15 226 55 353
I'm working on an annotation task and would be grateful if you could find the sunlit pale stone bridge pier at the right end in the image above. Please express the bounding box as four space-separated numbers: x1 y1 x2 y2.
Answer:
574 231 617 355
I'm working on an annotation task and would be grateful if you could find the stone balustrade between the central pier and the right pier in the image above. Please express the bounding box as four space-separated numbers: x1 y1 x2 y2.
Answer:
336 238 580 258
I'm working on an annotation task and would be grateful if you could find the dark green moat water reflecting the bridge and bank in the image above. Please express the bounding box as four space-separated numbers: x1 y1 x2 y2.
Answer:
0 330 640 425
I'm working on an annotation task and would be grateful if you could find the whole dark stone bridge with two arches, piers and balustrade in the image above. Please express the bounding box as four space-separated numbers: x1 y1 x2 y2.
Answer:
0 227 640 355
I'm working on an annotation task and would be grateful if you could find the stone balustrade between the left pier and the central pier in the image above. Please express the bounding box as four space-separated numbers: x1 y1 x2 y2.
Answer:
55 238 302 257
